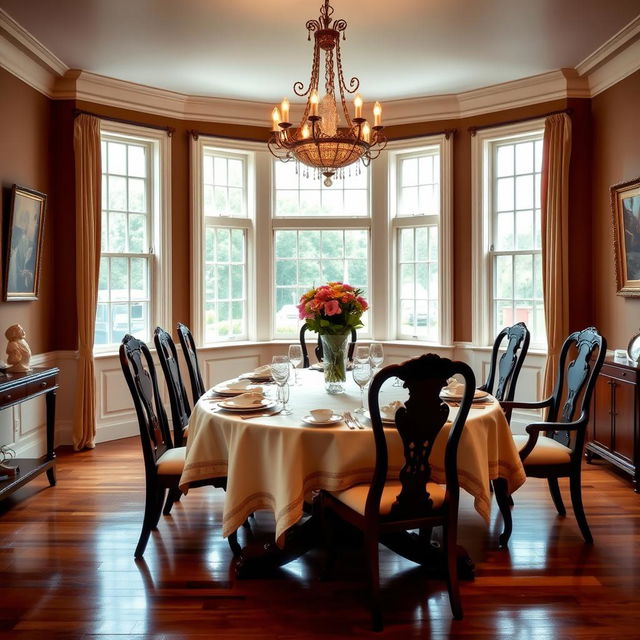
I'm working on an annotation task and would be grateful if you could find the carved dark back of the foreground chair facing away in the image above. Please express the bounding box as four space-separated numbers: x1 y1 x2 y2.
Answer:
365 354 476 520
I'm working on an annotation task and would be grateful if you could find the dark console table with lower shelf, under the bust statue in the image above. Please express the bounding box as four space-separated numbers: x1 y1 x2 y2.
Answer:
0 367 60 500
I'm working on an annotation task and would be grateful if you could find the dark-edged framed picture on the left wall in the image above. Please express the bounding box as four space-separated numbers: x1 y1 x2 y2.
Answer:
4 184 47 302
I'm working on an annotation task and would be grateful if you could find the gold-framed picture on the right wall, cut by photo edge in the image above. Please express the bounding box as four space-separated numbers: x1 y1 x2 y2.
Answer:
610 177 640 297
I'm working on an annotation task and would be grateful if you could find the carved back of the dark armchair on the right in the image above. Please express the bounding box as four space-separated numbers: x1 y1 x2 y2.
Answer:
546 327 607 455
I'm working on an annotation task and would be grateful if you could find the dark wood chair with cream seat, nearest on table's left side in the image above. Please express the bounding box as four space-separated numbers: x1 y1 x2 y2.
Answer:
120 334 240 558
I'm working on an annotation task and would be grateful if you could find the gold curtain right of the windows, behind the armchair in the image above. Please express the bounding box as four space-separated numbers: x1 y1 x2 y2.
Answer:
541 113 571 398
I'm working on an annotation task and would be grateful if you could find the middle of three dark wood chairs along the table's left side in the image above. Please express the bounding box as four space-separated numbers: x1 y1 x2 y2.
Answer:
153 327 191 447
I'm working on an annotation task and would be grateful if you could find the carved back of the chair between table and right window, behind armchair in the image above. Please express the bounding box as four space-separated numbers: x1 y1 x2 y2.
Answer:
480 322 530 400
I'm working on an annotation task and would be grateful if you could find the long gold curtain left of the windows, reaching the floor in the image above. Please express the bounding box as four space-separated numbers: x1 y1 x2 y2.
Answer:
73 114 101 451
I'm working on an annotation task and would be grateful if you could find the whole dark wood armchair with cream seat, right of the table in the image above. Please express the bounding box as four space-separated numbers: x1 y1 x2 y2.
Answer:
502 327 607 543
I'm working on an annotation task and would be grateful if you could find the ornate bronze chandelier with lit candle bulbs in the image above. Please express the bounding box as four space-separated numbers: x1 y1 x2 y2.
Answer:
267 0 387 187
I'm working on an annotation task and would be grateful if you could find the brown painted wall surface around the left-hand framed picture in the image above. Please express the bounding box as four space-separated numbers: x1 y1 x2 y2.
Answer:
0 69 56 359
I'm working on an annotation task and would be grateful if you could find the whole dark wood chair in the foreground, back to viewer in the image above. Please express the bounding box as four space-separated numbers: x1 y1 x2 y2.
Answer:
320 354 476 631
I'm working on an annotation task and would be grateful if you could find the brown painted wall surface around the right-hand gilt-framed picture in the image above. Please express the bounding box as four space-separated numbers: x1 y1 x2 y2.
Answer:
585 71 640 356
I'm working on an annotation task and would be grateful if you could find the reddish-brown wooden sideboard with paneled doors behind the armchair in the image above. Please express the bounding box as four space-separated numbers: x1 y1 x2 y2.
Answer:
585 357 640 493
